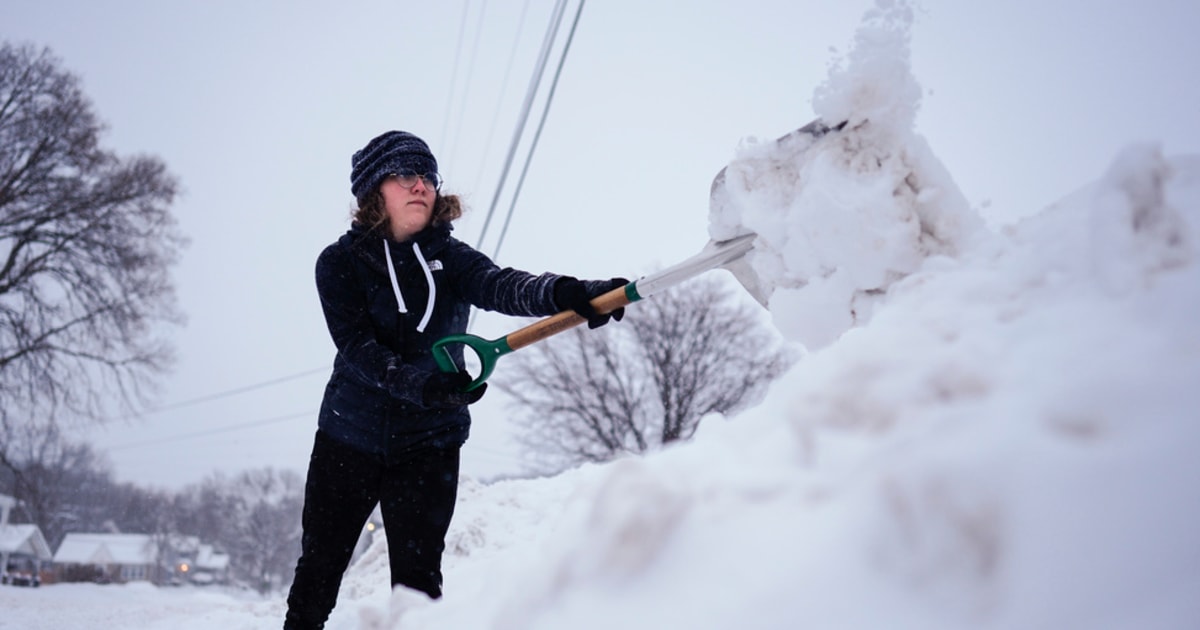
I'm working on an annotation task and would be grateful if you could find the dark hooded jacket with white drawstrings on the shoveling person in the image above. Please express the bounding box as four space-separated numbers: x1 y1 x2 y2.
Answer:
317 226 563 458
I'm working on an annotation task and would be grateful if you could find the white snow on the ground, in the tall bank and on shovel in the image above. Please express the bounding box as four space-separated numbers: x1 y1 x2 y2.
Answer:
0 2 1200 630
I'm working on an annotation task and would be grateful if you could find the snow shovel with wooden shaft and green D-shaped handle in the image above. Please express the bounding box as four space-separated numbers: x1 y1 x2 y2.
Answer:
433 120 845 391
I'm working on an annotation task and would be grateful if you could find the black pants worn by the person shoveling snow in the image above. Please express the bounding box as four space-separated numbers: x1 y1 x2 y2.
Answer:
283 431 460 629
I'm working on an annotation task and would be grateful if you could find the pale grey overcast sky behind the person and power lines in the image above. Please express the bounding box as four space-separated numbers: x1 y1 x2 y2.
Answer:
0 0 1200 487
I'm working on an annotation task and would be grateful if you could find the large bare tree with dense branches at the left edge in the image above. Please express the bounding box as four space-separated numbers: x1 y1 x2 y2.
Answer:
0 43 184 456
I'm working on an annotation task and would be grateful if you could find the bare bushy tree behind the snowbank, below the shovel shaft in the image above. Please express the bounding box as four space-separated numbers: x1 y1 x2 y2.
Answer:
494 276 792 473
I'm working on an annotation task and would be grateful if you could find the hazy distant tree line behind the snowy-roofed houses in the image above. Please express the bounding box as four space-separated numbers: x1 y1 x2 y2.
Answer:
0 424 304 593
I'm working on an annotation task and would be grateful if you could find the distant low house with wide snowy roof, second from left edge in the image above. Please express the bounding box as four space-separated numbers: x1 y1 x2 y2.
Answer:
54 534 162 582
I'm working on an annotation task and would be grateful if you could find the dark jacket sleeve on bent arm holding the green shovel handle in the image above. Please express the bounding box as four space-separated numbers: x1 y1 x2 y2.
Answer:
317 245 430 406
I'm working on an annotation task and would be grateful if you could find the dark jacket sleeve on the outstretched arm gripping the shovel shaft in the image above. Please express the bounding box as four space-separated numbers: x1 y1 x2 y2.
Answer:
452 241 563 317
